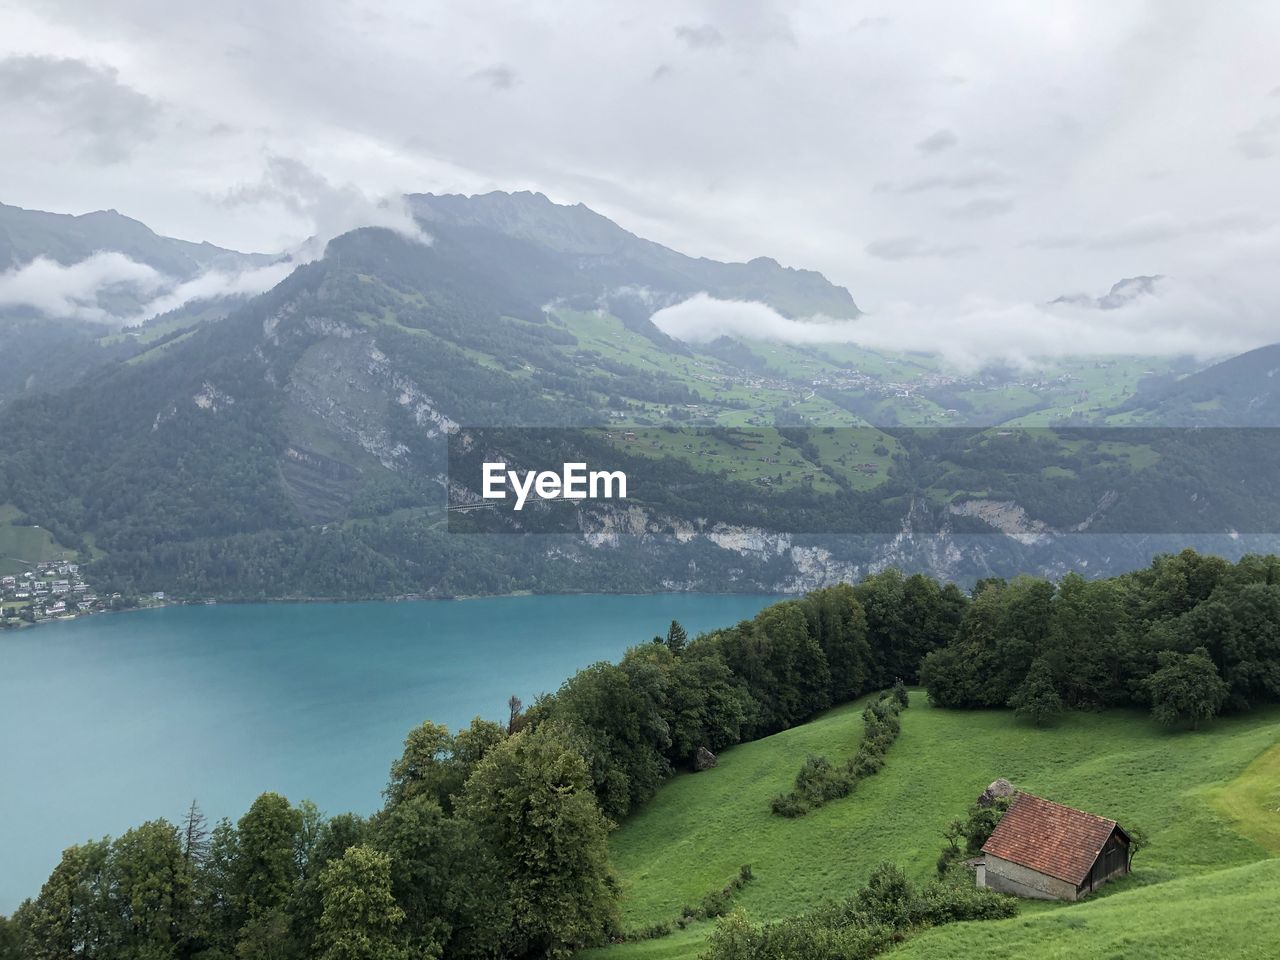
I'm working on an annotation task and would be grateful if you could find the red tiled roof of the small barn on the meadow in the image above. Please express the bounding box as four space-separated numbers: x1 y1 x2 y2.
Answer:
982 794 1124 886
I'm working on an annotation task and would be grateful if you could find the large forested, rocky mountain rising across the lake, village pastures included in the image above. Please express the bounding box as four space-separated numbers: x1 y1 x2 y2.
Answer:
0 195 1261 599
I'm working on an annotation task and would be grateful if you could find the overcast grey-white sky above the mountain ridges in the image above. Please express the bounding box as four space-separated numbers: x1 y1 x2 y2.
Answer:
0 0 1280 358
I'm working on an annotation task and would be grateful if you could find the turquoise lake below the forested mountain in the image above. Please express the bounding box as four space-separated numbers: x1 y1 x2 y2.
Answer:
0 594 777 914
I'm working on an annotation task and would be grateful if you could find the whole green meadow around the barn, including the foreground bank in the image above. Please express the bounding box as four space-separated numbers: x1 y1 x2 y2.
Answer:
591 691 1280 960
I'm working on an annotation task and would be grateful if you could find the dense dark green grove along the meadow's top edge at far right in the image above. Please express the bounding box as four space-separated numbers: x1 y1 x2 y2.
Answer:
920 550 1280 726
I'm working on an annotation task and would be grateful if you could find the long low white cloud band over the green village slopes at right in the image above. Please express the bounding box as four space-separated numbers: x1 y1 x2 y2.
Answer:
653 278 1280 370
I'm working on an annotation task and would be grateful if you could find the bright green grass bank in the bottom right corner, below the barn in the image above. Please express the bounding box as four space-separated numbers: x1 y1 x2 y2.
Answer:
887 860 1280 960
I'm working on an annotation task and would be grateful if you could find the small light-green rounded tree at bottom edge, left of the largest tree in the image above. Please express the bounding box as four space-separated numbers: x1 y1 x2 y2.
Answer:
316 846 407 960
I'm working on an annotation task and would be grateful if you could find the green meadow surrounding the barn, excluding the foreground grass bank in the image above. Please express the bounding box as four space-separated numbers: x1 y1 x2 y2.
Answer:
586 692 1280 960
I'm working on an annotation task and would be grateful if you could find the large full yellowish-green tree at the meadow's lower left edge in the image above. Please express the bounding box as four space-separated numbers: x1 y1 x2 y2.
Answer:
458 723 617 957
